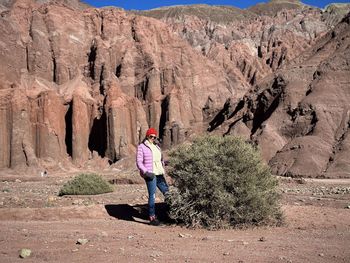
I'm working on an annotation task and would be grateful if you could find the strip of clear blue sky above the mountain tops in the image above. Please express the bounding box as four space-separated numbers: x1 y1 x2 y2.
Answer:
83 0 350 10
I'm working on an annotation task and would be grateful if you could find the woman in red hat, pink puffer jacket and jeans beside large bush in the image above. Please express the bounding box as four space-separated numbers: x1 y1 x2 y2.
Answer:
136 128 169 226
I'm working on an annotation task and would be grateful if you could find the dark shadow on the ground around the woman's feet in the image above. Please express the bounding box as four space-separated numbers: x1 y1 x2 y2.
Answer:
105 203 174 224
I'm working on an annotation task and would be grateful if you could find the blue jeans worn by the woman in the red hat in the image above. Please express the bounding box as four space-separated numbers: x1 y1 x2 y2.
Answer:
145 174 169 216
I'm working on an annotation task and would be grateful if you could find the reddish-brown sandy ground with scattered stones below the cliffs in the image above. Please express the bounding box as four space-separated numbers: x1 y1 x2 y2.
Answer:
0 171 350 263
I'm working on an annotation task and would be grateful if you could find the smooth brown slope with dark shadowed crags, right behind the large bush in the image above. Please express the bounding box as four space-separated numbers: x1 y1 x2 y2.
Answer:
206 15 350 178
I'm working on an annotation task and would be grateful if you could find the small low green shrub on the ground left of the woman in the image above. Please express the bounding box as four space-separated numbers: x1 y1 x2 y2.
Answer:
58 174 113 196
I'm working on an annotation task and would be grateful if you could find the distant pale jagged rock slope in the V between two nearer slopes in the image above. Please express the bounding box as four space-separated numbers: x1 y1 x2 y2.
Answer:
141 0 344 88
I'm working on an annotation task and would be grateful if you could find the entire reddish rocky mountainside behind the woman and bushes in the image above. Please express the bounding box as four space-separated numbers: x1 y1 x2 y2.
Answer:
0 0 350 177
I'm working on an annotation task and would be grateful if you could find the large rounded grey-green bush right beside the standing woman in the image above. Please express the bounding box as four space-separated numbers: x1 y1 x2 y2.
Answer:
166 136 282 229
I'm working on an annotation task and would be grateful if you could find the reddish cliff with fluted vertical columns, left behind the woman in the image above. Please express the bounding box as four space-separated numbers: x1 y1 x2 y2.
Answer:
0 0 242 171
